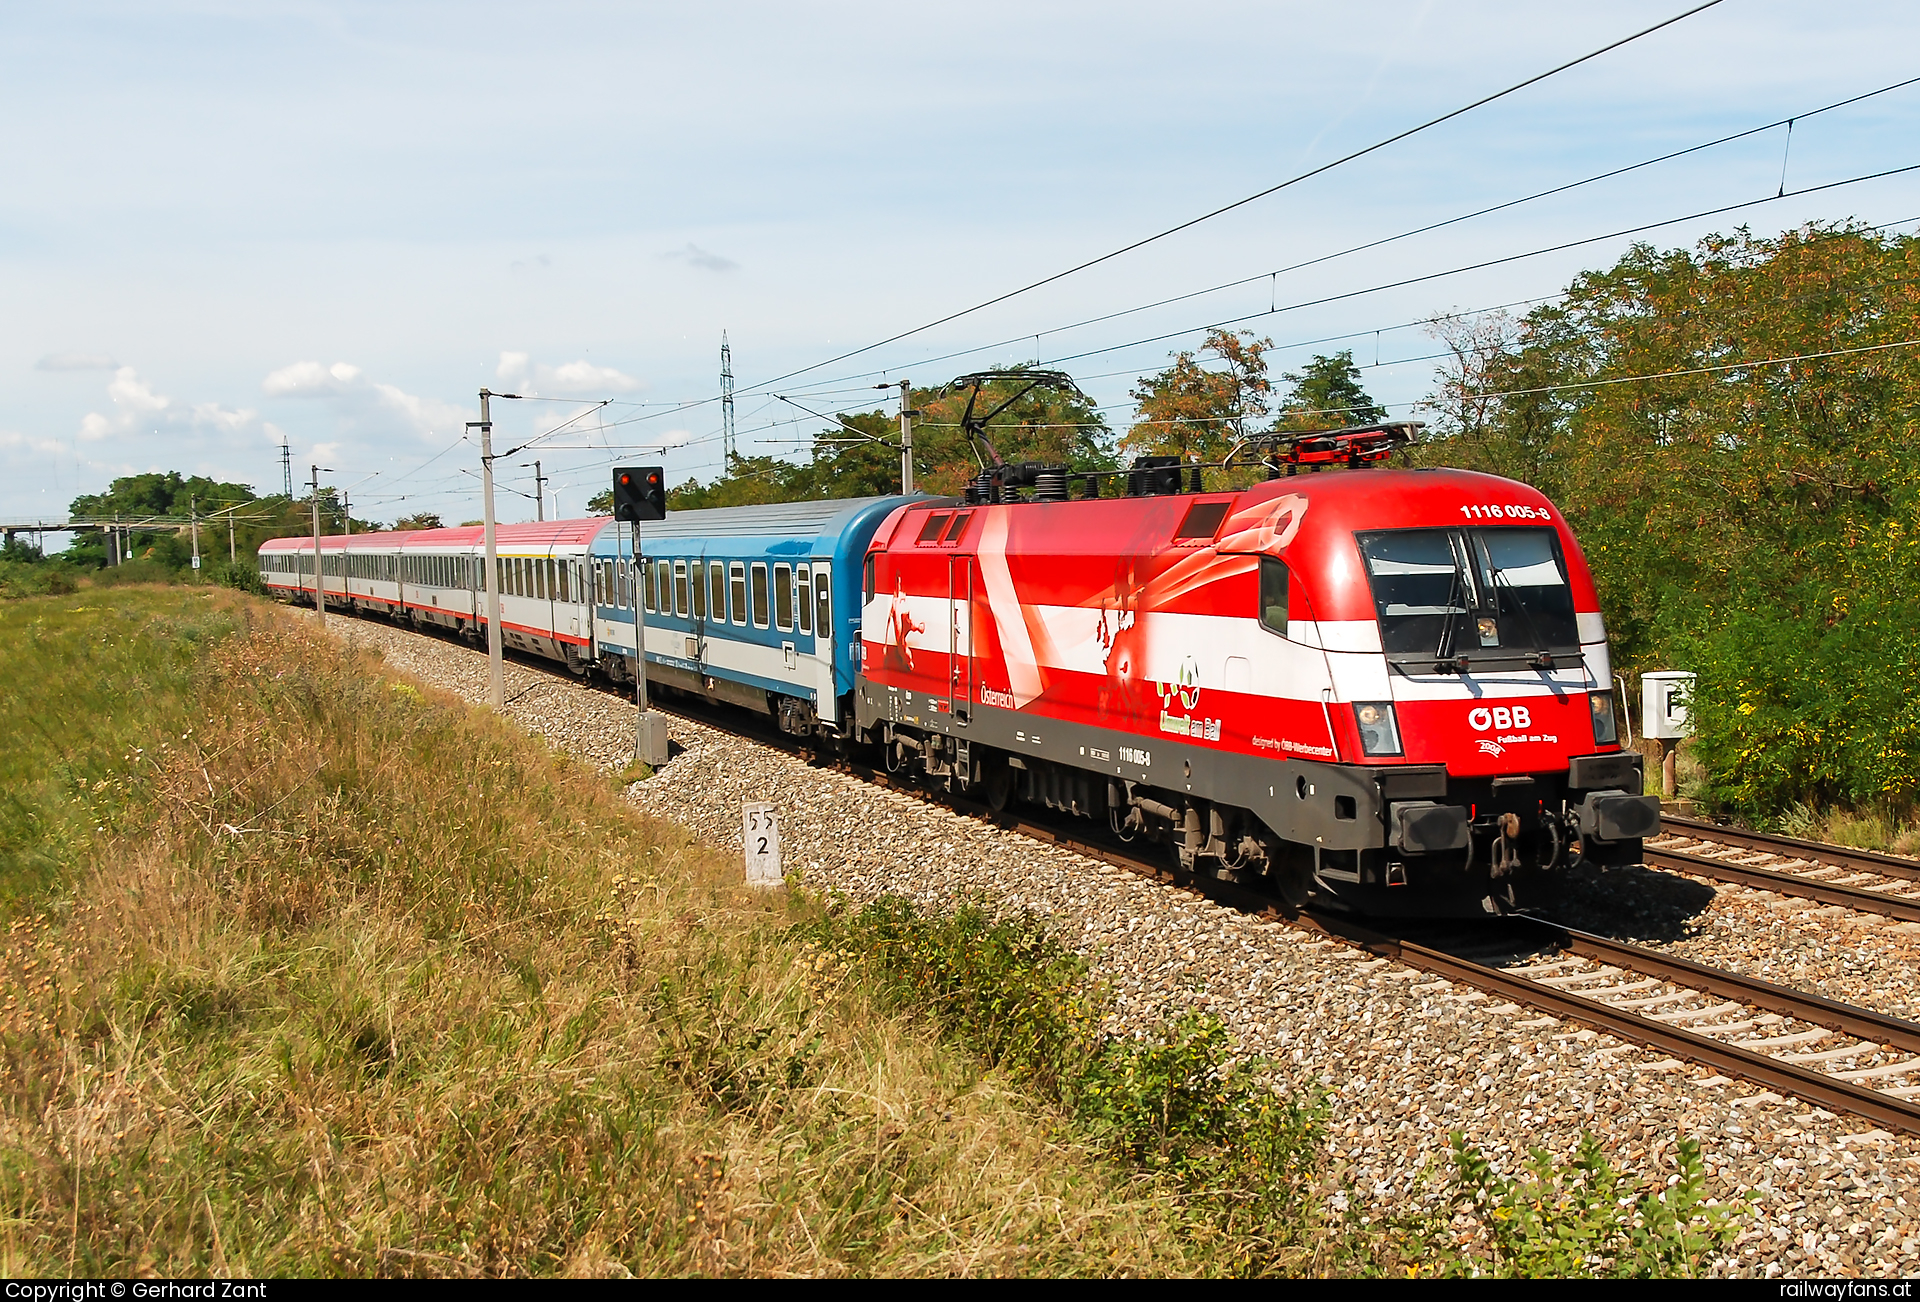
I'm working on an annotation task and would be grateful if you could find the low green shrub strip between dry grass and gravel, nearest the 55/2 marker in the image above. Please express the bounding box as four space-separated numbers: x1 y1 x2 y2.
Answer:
808 897 1325 1275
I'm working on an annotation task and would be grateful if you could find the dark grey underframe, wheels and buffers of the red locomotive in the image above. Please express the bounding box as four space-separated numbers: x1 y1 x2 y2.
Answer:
854 682 1659 916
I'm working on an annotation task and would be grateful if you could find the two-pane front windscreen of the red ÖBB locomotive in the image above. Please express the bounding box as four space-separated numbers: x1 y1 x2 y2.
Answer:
1354 528 1580 664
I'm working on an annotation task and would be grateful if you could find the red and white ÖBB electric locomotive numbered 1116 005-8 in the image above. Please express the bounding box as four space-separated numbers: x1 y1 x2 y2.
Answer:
856 426 1659 914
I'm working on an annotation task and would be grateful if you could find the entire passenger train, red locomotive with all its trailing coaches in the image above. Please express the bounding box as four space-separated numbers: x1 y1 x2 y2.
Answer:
263 428 1659 914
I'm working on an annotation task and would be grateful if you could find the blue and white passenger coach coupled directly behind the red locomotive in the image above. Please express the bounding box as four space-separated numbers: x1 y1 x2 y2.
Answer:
591 497 918 735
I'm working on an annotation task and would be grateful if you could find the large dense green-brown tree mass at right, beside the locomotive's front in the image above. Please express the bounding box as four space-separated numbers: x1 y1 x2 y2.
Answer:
1419 223 1920 814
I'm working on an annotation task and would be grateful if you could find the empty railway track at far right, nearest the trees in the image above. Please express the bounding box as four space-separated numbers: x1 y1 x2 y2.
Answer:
1645 816 1920 922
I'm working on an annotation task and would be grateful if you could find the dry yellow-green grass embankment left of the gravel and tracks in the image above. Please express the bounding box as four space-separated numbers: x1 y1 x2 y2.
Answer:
0 590 1208 1275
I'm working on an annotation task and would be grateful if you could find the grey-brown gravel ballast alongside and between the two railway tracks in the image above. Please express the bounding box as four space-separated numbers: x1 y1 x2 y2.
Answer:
330 618 1920 1277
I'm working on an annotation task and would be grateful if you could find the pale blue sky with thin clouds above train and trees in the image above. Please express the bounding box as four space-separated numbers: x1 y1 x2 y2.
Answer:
0 0 1920 518
